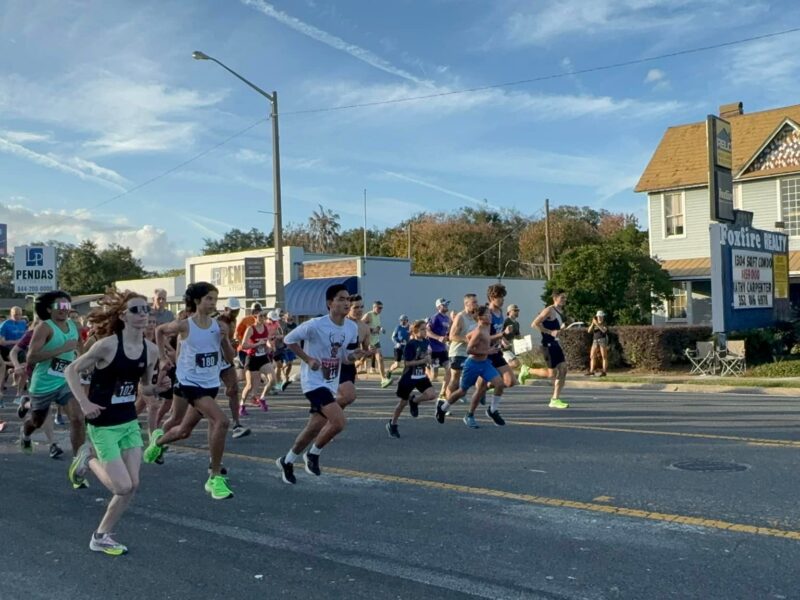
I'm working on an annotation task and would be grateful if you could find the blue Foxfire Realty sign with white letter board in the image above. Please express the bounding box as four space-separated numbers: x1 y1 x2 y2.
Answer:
710 223 789 332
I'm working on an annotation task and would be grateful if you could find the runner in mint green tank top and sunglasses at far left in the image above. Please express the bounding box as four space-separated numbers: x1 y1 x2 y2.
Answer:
20 290 87 489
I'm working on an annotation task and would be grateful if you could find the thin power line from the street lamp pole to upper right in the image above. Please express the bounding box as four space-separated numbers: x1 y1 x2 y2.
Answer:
281 27 800 116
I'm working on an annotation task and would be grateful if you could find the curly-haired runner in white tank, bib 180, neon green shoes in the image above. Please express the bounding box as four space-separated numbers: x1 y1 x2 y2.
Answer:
144 281 235 500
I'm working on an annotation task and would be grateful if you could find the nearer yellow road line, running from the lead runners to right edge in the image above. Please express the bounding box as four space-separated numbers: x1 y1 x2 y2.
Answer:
178 446 800 540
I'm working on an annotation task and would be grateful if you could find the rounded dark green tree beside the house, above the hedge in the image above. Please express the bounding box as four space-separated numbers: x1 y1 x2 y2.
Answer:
542 240 672 325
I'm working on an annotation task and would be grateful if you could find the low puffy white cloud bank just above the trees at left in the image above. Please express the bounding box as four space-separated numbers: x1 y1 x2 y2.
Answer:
0 198 192 269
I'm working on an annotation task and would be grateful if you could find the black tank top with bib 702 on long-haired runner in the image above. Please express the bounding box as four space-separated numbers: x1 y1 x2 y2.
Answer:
87 332 147 427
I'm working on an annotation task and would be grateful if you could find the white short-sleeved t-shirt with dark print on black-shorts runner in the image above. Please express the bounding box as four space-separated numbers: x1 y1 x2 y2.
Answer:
283 315 358 394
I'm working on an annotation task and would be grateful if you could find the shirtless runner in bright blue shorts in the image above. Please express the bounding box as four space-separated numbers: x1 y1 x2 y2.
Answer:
436 306 506 429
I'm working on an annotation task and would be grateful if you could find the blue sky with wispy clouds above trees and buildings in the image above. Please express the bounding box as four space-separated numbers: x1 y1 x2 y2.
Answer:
0 0 800 269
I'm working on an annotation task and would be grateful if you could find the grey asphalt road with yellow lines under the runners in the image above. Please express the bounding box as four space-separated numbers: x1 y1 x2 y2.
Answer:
0 382 800 600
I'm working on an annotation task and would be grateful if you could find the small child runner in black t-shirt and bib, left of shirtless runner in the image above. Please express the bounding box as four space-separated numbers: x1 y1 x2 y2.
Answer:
386 321 436 438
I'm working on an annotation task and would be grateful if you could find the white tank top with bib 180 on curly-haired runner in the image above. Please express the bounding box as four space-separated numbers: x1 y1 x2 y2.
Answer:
175 317 222 389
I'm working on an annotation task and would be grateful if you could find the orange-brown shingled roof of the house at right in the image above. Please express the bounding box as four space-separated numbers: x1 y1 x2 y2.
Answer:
634 104 800 192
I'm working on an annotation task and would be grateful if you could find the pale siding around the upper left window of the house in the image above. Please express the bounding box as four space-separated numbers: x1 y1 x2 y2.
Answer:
649 188 711 260
